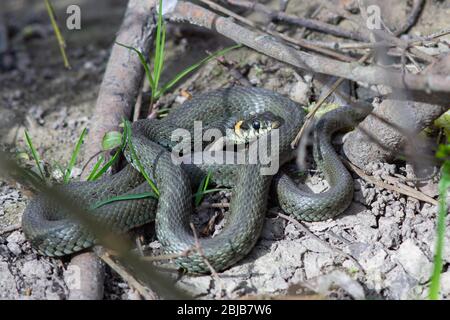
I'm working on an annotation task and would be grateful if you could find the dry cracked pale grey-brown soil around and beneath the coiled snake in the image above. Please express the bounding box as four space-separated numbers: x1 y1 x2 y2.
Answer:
0 0 450 299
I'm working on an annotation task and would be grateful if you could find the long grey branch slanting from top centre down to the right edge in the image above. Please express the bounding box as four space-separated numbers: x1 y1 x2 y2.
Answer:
168 1 450 93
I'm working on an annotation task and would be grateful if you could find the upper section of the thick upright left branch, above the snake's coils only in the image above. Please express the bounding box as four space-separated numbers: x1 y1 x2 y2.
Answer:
85 0 156 162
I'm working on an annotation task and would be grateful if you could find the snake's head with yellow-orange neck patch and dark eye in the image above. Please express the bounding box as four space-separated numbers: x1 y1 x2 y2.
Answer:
230 111 284 144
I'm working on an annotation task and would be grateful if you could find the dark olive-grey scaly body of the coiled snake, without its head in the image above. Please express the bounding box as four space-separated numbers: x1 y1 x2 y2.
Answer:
22 87 370 273
